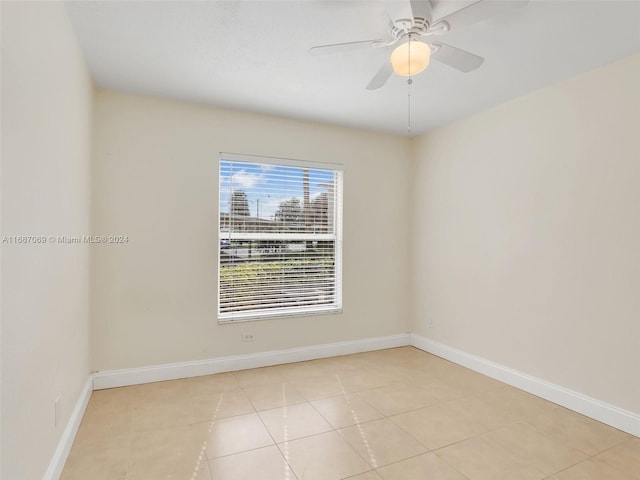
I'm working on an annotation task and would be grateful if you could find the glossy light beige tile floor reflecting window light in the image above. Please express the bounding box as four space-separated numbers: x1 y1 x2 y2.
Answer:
62 347 640 480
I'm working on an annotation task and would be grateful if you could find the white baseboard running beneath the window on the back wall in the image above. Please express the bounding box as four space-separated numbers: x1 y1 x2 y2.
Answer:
93 333 410 390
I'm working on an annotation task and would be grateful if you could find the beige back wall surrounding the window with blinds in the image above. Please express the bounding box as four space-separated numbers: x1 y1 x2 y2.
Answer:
91 92 410 370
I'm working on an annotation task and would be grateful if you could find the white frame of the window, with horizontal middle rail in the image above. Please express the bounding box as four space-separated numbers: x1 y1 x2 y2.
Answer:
216 152 344 324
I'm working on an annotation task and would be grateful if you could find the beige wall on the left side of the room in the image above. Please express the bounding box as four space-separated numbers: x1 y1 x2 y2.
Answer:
0 2 93 480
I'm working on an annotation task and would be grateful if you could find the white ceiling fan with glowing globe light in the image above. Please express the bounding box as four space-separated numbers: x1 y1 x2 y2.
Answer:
309 0 528 90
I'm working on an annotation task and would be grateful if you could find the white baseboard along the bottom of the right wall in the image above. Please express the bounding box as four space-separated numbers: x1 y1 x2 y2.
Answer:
411 333 640 437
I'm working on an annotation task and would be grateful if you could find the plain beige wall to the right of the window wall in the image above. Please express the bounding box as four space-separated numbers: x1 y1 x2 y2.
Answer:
411 51 640 412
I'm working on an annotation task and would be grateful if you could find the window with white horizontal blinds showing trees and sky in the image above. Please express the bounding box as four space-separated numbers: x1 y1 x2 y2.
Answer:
218 154 342 322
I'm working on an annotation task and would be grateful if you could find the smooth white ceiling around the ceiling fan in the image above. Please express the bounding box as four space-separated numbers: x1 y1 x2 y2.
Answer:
67 0 640 135
